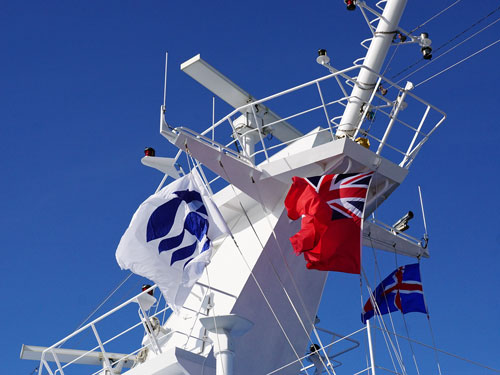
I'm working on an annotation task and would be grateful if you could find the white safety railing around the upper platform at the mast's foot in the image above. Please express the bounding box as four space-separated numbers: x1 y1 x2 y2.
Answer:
162 65 446 176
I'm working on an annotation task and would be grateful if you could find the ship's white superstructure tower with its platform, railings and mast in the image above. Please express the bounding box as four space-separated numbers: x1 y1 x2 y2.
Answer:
22 0 445 375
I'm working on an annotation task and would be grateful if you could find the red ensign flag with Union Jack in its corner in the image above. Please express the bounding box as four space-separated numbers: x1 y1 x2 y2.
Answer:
285 172 373 274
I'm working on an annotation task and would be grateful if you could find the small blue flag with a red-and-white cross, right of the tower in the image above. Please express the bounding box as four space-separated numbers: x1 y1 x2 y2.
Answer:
361 263 427 323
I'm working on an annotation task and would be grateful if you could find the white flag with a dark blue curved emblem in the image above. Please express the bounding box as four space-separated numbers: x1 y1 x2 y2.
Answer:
116 172 229 313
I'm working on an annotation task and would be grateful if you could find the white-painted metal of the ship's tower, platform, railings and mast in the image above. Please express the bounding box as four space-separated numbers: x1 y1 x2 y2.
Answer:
20 0 450 375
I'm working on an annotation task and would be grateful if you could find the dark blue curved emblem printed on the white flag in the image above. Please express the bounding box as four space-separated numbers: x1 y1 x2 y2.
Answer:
146 190 210 267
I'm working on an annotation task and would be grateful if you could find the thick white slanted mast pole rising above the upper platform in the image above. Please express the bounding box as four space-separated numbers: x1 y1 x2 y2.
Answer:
336 0 407 138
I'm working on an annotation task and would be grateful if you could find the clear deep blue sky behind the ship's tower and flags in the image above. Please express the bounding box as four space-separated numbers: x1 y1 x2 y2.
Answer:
0 0 500 375
